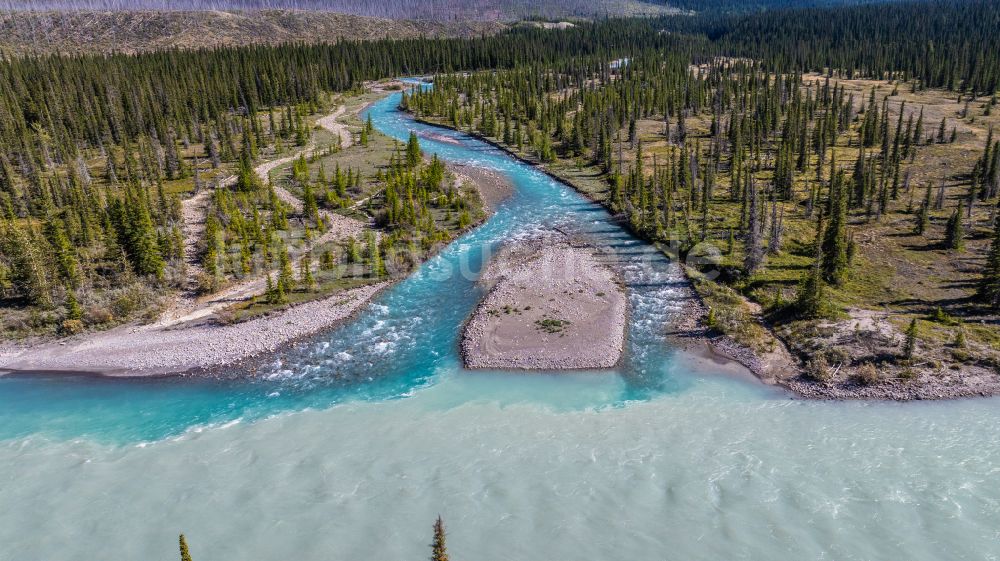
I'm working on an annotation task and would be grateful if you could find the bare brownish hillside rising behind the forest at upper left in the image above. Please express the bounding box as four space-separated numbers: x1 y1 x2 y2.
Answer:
0 10 504 54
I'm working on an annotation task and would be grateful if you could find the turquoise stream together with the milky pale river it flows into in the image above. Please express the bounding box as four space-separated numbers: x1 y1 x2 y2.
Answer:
0 89 1000 561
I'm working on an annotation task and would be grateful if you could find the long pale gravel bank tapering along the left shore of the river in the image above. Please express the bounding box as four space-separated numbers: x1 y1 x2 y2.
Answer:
0 282 389 377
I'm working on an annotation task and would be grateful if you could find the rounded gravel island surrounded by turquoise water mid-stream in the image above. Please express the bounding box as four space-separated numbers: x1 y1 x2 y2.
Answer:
462 234 628 370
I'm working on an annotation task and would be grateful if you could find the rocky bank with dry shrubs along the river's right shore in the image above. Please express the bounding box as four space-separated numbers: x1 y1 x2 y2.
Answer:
668 290 1000 401
